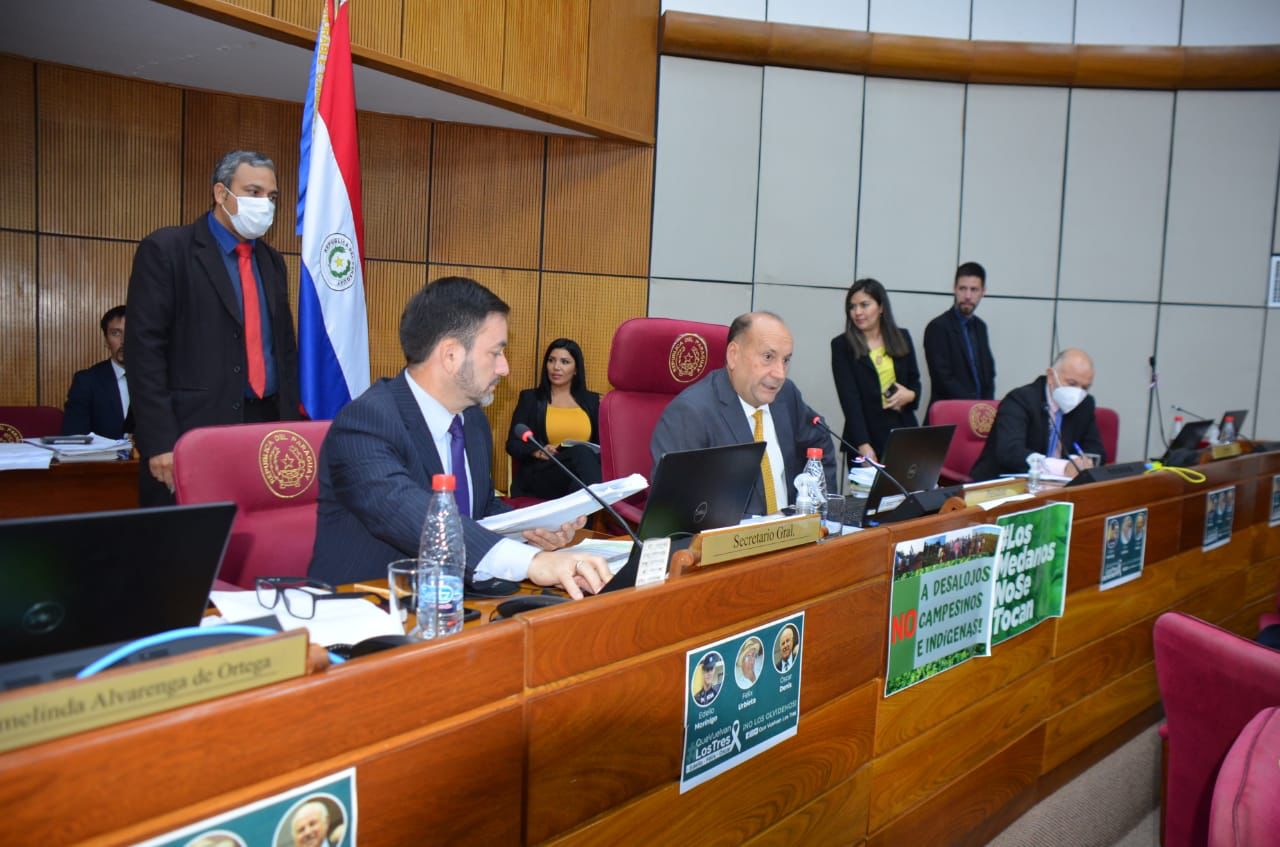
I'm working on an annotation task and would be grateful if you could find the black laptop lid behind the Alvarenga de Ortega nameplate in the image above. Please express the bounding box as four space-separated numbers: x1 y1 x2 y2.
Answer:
0 503 236 663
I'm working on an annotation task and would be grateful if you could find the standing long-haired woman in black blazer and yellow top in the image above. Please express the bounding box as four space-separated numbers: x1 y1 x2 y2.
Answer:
831 279 920 461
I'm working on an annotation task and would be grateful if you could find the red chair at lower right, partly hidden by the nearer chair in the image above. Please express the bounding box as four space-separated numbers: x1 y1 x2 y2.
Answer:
1153 612 1280 847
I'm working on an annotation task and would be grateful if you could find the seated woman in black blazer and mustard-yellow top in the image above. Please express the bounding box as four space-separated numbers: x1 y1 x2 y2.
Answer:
507 338 600 499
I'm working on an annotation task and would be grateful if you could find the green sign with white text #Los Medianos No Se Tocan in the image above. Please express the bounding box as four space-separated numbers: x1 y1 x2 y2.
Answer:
991 503 1075 646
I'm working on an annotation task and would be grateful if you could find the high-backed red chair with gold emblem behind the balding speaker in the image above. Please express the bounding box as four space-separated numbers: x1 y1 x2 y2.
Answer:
600 317 728 523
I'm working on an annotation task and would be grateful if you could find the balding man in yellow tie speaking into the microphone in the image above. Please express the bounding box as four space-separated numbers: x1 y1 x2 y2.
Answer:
649 312 838 514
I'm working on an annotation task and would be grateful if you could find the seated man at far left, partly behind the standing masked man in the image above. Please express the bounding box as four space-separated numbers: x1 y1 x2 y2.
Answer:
63 306 133 439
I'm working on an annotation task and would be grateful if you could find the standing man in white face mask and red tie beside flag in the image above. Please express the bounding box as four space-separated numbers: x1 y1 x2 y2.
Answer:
125 150 301 505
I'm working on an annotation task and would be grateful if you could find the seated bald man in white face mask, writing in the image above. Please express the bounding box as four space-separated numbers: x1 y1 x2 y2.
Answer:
970 348 1111 480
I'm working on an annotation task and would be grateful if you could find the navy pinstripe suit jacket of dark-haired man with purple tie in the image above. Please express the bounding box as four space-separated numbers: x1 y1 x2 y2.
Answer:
308 372 507 585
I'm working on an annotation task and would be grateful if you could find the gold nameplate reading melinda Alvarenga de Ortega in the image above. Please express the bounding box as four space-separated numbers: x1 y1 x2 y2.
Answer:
0 629 307 752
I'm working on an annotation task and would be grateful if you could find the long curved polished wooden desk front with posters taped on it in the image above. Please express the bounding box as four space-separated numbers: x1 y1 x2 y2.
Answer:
0 454 1280 846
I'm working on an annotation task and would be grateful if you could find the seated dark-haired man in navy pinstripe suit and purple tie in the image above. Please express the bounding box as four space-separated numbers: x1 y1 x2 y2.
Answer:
307 276 609 598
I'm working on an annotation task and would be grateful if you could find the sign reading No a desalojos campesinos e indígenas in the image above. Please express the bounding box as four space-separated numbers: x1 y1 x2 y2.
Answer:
884 525 1000 697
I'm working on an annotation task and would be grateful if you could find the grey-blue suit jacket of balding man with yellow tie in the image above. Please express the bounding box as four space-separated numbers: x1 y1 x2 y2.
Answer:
649 367 840 514
